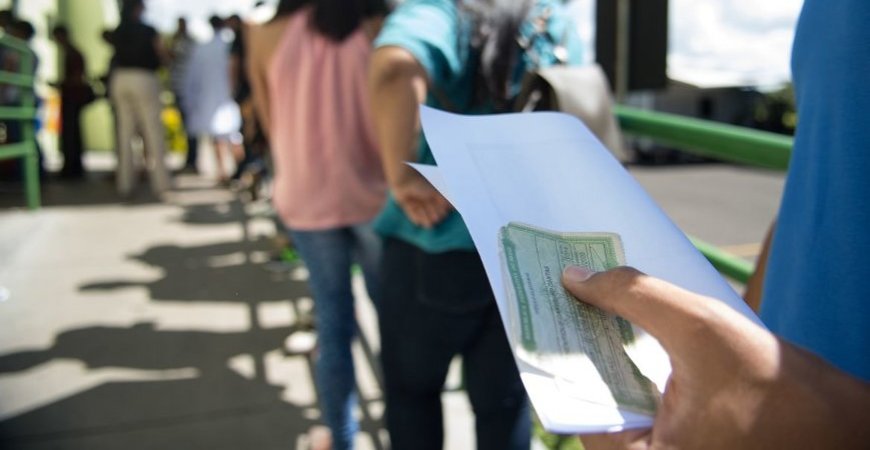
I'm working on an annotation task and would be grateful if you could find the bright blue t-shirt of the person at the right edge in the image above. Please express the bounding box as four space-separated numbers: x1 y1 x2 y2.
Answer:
761 0 870 380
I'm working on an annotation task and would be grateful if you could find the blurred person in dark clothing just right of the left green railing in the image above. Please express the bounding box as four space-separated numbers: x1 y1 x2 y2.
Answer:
52 25 94 179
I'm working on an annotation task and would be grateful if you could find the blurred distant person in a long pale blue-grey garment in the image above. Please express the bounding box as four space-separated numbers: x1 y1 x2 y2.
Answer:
181 16 241 185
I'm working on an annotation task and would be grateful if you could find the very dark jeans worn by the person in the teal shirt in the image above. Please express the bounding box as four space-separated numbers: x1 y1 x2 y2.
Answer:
378 239 531 450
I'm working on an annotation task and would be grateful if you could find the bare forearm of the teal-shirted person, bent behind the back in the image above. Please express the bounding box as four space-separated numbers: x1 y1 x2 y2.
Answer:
369 47 426 185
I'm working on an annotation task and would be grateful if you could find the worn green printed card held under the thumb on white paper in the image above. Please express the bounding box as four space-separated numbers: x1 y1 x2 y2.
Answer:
499 222 660 415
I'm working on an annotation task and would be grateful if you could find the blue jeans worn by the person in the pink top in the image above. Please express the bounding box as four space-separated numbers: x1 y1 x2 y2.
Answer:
290 225 381 450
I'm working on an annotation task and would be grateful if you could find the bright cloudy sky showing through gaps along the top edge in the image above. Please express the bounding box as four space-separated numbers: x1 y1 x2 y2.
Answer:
141 0 803 86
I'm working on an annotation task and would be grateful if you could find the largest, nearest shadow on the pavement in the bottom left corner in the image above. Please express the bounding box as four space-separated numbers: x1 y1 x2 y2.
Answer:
0 323 313 450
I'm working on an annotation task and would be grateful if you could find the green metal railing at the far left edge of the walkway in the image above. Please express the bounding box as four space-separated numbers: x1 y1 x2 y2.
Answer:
0 34 40 209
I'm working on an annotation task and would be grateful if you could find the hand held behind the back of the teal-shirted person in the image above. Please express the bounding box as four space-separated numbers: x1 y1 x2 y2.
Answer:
390 166 451 228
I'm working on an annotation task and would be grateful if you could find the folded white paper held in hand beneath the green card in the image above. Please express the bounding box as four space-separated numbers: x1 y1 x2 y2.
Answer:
413 107 761 433
